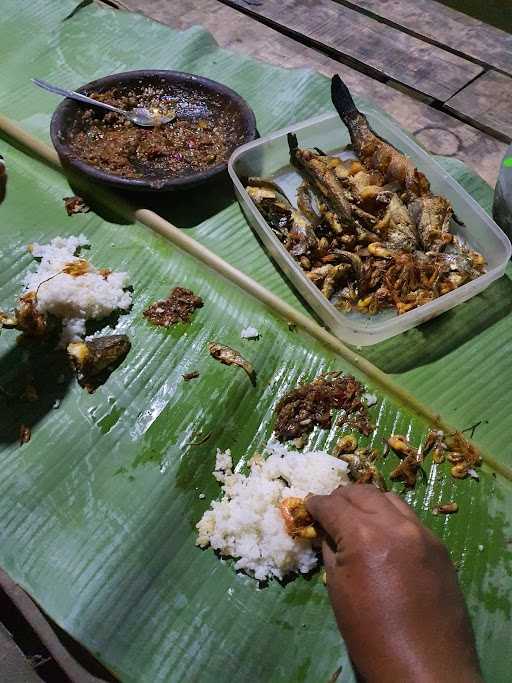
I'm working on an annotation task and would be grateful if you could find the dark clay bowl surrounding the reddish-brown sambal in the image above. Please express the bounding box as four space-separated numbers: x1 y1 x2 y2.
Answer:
50 70 258 192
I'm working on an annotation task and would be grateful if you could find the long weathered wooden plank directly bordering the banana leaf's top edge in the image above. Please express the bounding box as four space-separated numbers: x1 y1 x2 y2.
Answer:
119 0 506 185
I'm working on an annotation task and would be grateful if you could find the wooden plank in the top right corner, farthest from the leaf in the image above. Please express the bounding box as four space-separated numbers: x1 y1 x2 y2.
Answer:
336 0 512 74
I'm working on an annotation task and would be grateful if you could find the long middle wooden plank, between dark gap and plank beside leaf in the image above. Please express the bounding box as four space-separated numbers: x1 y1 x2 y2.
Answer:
217 0 482 102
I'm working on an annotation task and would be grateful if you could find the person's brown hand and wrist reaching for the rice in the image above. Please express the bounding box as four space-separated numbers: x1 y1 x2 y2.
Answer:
306 484 483 683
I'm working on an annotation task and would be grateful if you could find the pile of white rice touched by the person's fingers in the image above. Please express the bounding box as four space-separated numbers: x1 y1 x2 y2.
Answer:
196 440 348 581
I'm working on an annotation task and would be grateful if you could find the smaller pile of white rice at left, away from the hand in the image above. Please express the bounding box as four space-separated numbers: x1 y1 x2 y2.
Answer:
24 235 132 347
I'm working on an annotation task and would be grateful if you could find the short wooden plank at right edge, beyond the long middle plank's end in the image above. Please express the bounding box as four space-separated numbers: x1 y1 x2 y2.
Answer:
446 71 512 140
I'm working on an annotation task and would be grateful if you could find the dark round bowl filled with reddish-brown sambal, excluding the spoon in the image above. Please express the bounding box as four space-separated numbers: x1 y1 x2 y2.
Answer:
50 70 257 191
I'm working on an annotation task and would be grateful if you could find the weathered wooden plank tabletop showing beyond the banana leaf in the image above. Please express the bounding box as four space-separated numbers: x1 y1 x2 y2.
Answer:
115 0 512 185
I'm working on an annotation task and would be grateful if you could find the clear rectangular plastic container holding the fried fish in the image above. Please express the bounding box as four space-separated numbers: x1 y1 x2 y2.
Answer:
228 114 511 346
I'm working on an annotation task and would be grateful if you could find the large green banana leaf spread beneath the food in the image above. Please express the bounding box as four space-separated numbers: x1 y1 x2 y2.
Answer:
0 0 512 683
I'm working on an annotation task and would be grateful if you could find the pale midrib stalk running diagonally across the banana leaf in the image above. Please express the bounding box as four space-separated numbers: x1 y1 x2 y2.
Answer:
0 114 512 480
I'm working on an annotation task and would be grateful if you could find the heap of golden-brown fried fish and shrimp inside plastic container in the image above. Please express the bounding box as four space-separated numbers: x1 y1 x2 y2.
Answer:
247 76 486 320
